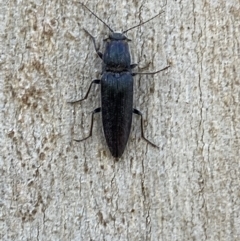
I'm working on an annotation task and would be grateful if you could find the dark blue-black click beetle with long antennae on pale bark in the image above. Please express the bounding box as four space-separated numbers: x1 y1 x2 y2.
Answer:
70 3 170 158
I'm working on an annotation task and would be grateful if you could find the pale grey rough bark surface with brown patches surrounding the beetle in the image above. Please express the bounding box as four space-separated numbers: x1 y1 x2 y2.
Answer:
0 0 240 241
